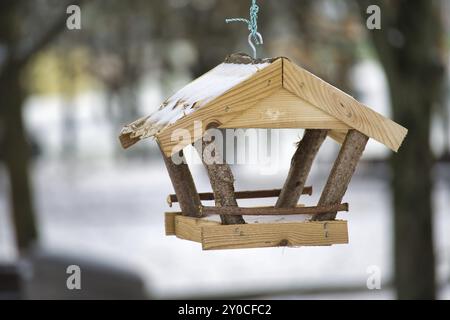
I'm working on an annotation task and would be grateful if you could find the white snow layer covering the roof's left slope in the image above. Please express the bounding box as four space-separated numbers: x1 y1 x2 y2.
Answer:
121 61 270 146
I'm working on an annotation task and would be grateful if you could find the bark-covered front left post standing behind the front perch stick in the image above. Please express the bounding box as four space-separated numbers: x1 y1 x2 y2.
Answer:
194 124 245 224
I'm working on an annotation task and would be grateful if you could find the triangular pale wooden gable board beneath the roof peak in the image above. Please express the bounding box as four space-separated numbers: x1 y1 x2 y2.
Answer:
220 88 350 130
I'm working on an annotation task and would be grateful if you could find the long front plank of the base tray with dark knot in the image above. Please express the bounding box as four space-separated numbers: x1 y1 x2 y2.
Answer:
202 221 348 250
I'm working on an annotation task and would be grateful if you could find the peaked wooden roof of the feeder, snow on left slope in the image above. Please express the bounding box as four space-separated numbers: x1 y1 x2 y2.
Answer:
120 54 407 155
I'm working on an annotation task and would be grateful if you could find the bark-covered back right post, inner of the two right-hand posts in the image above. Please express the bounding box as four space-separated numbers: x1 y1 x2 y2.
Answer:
275 129 328 208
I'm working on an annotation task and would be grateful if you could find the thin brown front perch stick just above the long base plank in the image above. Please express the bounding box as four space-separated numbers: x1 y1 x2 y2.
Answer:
201 203 348 216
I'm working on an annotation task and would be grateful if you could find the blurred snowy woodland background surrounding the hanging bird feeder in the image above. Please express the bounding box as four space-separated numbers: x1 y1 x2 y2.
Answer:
0 0 450 299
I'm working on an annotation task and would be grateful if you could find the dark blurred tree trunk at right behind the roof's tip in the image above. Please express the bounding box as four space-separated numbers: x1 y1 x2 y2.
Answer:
358 0 445 299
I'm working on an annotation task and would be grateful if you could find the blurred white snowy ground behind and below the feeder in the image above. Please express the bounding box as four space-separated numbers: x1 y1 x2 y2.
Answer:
0 154 450 299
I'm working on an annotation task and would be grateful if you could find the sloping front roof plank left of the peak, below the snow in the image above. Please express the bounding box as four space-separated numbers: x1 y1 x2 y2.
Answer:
157 59 282 156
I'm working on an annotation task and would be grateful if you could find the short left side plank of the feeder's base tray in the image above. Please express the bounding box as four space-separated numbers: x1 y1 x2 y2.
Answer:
175 215 220 242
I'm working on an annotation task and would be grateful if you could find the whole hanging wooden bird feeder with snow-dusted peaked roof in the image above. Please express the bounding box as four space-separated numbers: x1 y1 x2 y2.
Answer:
120 54 407 250
